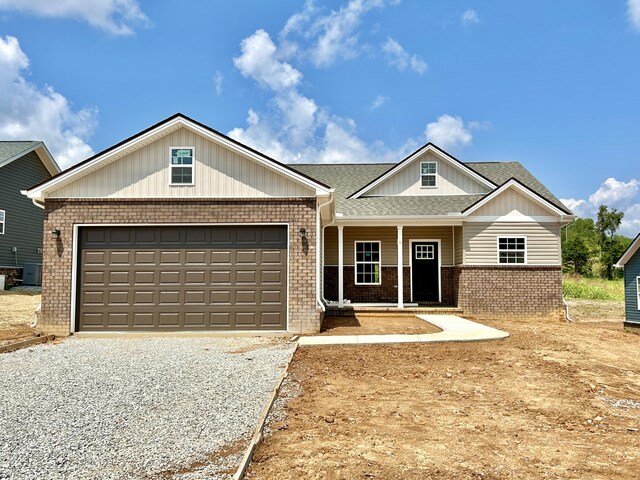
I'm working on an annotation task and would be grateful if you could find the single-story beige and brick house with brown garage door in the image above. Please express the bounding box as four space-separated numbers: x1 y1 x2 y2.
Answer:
26 114 574 335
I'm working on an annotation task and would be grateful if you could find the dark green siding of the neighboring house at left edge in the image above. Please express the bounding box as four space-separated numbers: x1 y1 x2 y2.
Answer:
0 152 51 267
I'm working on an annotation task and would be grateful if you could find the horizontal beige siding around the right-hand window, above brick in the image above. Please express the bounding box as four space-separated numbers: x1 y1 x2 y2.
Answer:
464 222 560 265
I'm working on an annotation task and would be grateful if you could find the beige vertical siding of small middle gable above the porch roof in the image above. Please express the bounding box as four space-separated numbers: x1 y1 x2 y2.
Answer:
366 152 489 196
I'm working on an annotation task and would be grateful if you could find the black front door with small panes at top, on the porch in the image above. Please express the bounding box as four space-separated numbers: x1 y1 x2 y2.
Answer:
411 242 440 302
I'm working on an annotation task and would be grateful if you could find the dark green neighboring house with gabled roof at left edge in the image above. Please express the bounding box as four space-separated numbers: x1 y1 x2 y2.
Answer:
0 141 60 286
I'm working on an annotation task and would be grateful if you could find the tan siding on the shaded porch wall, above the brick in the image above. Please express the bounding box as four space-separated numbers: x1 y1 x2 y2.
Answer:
324 227 453 266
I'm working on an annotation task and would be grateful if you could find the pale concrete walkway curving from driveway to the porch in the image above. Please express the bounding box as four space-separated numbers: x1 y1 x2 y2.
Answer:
298 315 509 346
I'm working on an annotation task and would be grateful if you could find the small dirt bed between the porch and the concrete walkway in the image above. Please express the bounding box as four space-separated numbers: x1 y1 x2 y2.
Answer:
320 316 441 335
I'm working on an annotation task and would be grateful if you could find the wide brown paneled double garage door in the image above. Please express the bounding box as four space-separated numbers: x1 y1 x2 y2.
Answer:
77 226 287 331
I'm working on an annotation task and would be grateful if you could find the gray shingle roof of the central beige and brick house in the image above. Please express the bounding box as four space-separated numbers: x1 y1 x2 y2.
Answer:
291 162 566 216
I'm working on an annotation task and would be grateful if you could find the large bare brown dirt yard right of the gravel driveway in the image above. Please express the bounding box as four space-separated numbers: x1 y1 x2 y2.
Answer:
248 302 640 479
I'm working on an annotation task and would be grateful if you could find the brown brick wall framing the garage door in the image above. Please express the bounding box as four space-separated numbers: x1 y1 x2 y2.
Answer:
40 198 321 335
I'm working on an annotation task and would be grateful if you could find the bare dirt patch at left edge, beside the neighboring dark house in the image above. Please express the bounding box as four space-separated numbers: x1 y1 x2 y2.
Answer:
0 288 40 345
